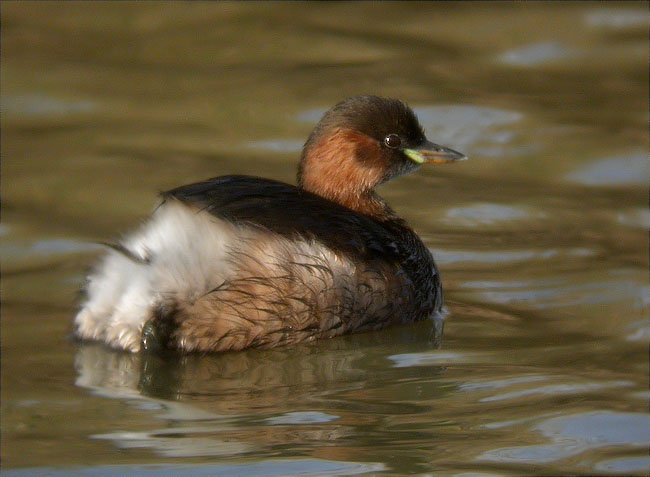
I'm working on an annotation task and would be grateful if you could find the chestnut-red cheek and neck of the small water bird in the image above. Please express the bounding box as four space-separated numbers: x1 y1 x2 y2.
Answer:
298 129 397 221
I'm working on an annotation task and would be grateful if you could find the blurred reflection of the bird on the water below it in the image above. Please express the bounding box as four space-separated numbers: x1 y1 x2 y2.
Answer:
75 322 442 460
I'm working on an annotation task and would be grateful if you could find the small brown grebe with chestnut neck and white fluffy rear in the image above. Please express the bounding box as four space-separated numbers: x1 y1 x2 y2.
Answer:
73 95 466 353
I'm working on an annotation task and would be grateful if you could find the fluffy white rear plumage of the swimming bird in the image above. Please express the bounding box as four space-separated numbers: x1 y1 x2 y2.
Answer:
75 202 241 351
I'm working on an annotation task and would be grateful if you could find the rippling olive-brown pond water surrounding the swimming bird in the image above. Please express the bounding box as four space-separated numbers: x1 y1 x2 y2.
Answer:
0 2 650 476
